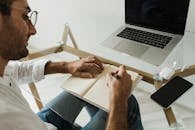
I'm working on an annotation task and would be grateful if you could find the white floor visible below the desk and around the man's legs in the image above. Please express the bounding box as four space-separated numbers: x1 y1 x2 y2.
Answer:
20 52 195 130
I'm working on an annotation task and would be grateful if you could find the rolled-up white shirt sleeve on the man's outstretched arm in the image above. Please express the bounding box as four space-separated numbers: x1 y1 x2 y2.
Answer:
4 59 49 84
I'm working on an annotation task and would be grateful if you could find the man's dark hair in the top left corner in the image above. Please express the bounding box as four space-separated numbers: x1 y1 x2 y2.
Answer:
0 0 16 15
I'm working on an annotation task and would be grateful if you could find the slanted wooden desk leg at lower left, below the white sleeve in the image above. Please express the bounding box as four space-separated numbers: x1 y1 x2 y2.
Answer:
29 83 43 110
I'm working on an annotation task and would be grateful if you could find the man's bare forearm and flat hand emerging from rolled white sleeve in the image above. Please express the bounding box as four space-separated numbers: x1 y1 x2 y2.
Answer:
44 56 103 78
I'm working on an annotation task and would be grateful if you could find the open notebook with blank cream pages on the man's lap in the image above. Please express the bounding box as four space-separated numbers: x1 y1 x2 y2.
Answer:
61 64 142 111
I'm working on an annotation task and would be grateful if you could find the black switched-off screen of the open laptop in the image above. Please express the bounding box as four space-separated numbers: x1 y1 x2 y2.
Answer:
125 0 189 34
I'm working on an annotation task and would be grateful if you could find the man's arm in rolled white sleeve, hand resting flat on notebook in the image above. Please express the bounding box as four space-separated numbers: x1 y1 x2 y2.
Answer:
4 56 103 84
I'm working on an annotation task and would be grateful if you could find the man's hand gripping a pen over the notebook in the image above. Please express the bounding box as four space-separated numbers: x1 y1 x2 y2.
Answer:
107 66 132 102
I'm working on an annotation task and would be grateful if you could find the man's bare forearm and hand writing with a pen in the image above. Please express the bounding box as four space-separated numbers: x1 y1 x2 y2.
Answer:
106 66 132 130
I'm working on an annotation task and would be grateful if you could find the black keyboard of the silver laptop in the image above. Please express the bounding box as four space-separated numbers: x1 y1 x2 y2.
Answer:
117 28 172 49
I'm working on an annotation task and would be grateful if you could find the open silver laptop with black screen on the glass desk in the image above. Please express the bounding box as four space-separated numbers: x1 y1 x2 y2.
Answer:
101 0 190 65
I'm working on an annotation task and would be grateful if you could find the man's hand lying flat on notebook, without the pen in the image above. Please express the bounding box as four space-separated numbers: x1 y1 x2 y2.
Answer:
67 56 103 78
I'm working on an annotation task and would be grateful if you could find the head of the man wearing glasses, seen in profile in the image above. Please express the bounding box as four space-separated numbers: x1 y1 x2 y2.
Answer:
0 0 36 60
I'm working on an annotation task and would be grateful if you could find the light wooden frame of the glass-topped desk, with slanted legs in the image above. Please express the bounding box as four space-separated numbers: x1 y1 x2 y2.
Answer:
25 24 195 126
